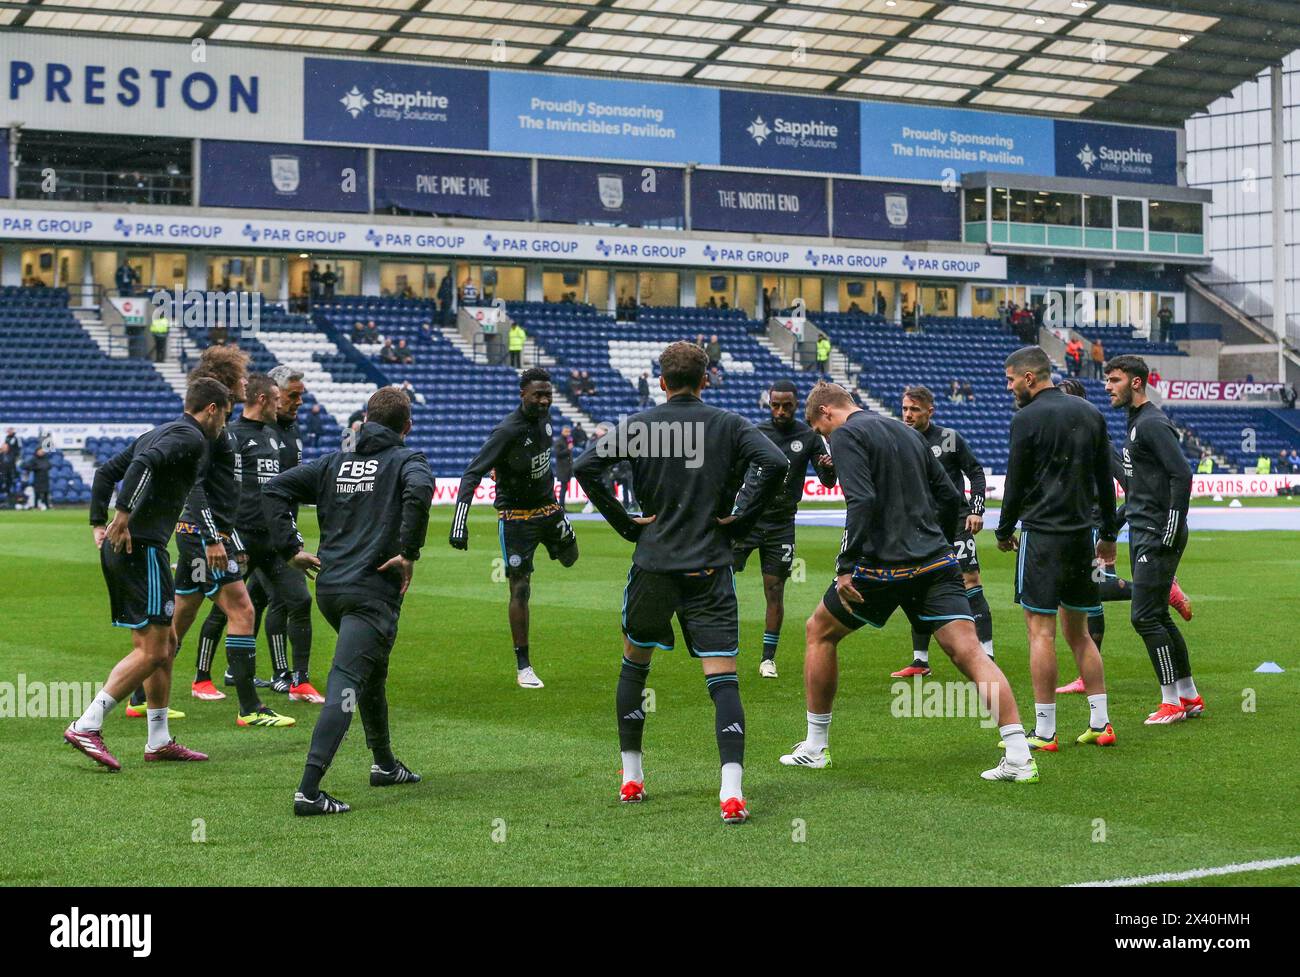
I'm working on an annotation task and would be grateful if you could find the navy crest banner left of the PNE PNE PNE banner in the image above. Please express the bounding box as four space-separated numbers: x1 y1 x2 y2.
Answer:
199 139 371 213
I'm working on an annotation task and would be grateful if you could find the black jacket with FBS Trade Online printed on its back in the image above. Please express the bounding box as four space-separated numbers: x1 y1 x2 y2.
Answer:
261 421 434 604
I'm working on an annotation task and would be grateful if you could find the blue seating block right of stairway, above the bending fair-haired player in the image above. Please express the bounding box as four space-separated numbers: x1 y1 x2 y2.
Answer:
811 313 1021 473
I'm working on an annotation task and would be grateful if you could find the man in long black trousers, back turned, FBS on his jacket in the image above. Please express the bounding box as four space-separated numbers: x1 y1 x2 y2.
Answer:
265 387 433 816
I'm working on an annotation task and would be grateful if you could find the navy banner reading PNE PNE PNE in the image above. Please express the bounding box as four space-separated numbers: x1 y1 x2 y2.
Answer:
374 149 533 221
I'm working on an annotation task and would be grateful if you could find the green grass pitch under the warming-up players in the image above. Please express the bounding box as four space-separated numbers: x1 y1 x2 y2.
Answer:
0 509 1300 885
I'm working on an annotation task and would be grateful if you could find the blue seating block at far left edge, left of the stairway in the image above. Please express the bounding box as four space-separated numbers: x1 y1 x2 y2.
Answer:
0 280 181 424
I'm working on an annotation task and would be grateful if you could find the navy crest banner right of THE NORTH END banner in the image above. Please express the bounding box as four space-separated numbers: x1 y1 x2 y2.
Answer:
832 179 961 240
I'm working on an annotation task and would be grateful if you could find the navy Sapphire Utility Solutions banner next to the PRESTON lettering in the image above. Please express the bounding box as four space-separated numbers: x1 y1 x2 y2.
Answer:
303 57 488 149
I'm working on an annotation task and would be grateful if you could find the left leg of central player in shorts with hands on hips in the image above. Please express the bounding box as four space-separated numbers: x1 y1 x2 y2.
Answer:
614 565 680 804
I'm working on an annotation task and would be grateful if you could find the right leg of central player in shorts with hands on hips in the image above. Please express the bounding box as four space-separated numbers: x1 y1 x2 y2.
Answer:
677 566 749 824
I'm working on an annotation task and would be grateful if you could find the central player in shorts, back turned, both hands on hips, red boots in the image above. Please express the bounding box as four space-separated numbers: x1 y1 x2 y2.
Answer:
573 343 789 824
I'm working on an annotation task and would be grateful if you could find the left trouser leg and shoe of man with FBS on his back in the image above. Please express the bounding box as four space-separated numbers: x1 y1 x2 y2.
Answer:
294 594 387 816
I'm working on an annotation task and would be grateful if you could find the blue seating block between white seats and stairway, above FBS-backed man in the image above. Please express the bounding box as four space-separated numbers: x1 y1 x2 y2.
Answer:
316 299 569 477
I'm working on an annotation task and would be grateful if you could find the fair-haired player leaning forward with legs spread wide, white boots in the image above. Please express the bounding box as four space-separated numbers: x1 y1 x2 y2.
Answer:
781 382 1039 783
